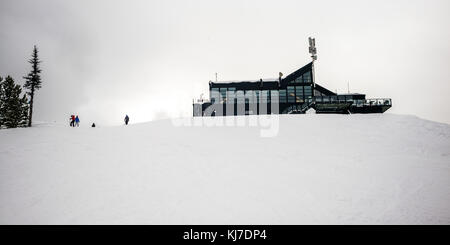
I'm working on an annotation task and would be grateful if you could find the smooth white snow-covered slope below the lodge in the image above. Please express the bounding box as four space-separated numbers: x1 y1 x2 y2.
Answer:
0 114 450 224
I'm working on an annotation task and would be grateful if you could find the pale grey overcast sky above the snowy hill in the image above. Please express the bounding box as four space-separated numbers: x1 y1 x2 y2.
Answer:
0 0 450 125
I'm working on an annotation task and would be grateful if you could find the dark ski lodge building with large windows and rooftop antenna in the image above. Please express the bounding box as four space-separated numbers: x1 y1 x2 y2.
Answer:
193 38 392 117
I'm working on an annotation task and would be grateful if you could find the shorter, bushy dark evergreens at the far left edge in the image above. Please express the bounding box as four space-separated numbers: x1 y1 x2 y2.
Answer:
0 76 28 128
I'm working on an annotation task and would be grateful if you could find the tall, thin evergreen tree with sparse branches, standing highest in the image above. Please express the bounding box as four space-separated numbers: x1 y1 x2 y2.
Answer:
23 45 42 127
